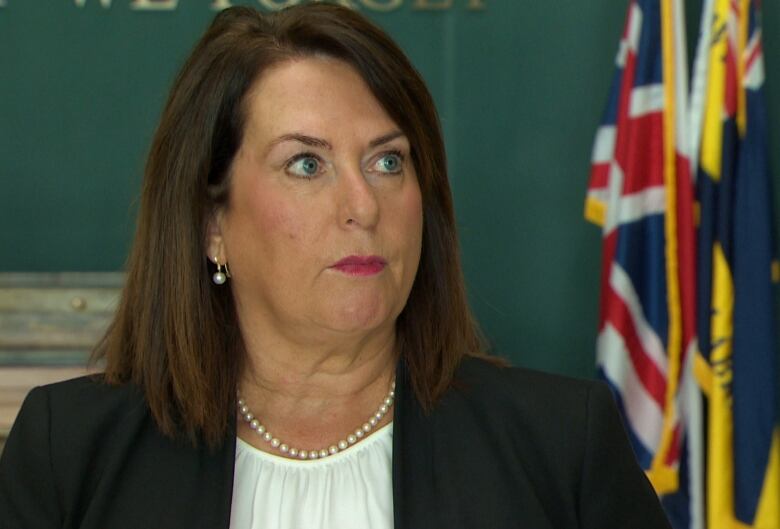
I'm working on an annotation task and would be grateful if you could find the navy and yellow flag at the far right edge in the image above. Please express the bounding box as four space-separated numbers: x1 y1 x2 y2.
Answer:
692 0 780 529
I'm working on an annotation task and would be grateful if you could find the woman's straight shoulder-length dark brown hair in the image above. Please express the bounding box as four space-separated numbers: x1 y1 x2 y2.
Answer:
96 4 484 445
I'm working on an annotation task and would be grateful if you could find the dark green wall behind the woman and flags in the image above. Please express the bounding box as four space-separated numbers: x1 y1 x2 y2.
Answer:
0 0 780 376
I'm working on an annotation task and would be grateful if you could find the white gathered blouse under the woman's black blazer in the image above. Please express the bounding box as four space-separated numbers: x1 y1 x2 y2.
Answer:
230 423 393 529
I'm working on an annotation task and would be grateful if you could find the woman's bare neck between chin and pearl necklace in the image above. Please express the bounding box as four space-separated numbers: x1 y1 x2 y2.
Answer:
238 324 396 450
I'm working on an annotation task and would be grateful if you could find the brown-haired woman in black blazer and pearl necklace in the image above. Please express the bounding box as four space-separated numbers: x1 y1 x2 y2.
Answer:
0 4 668 529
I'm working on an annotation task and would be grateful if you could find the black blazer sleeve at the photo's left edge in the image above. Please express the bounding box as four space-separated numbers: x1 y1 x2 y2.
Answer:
0 388 62 529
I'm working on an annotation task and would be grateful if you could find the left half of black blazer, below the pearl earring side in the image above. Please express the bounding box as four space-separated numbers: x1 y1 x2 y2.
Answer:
0 376 235 528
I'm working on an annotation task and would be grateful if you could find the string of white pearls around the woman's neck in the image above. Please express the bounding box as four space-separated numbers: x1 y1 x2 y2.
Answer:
238 379 395 459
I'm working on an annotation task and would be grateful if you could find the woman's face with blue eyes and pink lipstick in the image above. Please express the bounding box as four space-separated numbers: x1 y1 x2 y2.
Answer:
209 57 423 340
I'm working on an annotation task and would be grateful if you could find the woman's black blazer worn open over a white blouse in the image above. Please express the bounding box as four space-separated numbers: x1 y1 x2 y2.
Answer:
0 359 669 529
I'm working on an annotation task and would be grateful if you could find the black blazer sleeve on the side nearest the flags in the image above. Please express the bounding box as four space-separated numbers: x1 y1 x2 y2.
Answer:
579 384 671 529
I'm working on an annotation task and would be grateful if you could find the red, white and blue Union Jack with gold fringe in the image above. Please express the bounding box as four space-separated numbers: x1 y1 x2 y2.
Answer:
585 0 702 528
